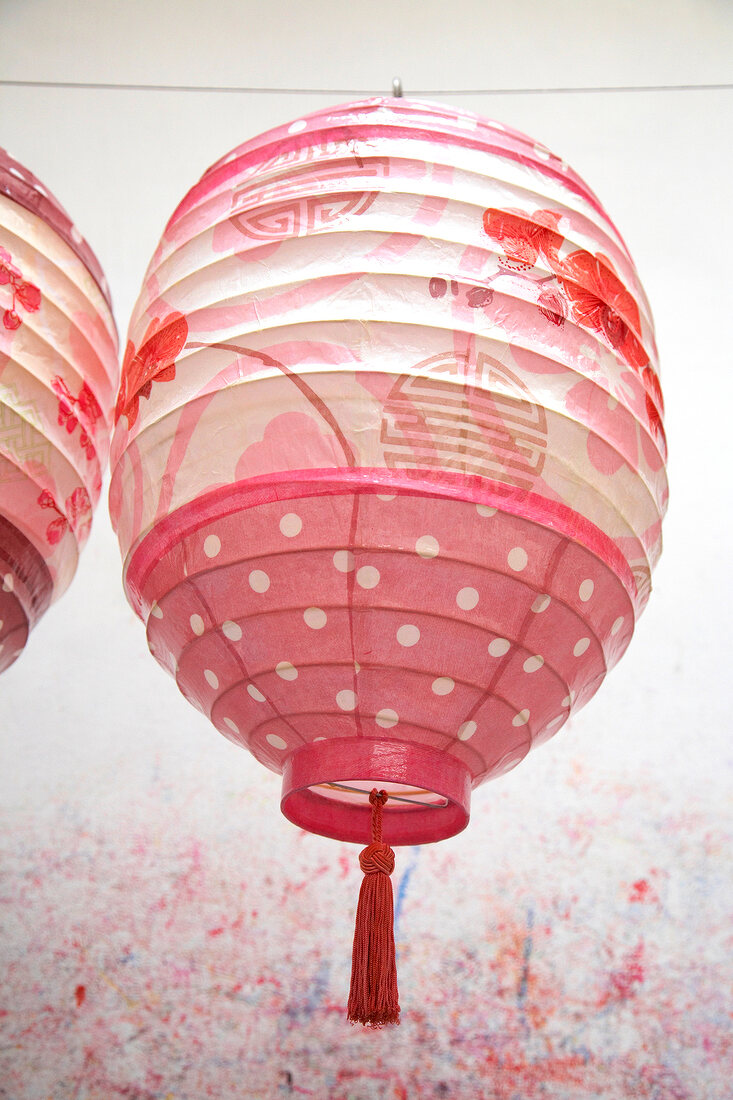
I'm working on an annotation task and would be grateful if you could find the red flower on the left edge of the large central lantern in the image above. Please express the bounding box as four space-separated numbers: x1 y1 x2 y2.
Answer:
114 312 188 428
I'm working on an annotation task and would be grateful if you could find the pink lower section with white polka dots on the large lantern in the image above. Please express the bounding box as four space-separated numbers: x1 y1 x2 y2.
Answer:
137 493 633 792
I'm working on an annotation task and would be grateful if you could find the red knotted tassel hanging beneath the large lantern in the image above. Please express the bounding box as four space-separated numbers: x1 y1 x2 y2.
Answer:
348 789 400 1027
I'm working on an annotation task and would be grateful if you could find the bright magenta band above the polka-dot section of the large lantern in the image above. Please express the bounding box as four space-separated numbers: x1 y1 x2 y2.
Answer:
124 468 636 617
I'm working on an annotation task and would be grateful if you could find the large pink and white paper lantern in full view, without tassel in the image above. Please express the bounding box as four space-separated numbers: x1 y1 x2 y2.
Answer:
110 99 667 1022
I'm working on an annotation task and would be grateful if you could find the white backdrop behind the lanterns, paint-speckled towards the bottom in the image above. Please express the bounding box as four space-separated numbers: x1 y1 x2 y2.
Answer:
0 0 733 1100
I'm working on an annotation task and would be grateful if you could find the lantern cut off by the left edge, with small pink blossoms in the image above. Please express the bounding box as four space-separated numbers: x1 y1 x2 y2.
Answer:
0 150 119 671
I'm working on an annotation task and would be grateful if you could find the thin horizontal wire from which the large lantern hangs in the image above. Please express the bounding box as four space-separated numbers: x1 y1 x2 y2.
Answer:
0 80 733 98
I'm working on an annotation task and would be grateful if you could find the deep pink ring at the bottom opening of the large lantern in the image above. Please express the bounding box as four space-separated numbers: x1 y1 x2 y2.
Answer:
280 738 471 846
